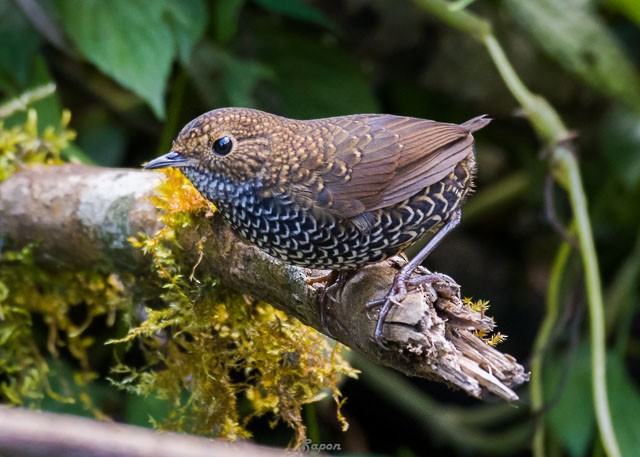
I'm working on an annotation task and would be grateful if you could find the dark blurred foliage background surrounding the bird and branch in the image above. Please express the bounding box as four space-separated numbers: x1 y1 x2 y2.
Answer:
0 0 640 456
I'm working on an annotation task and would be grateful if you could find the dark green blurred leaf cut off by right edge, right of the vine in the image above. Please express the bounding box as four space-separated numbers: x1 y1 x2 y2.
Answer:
599 106 640 190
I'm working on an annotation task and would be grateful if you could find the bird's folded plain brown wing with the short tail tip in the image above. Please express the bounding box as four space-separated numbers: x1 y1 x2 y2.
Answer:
292 114 490 218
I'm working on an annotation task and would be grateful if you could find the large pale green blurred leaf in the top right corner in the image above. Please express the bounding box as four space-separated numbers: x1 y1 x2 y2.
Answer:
505 0 640 108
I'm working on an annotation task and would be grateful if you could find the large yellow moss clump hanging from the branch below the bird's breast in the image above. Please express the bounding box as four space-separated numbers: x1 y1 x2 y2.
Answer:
117 166 356 445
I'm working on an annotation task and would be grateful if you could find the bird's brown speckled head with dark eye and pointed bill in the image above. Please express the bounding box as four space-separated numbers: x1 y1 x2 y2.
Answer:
144 108 286 182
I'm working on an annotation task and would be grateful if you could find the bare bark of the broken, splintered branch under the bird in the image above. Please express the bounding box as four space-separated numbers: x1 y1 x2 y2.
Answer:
0 165 528 400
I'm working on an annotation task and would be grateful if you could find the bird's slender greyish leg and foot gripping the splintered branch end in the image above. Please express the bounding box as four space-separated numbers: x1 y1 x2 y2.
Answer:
367 209 461 348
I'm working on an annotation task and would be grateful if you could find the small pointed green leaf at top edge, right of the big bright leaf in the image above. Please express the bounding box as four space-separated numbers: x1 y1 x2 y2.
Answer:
166 0 208 66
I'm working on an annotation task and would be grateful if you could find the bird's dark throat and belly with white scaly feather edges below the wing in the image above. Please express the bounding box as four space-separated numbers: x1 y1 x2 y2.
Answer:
182 155 475 270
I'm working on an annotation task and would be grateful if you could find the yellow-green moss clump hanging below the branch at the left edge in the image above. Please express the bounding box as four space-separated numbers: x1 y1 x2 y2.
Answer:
0 247 130 416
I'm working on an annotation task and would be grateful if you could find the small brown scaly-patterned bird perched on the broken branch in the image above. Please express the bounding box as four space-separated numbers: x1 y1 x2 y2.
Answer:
144 107 491 347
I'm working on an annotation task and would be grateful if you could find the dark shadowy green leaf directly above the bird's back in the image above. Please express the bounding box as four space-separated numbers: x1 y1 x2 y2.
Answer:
252 25 379 118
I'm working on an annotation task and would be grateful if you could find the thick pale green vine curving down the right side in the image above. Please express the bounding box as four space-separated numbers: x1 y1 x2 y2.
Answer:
413 0 620 457
